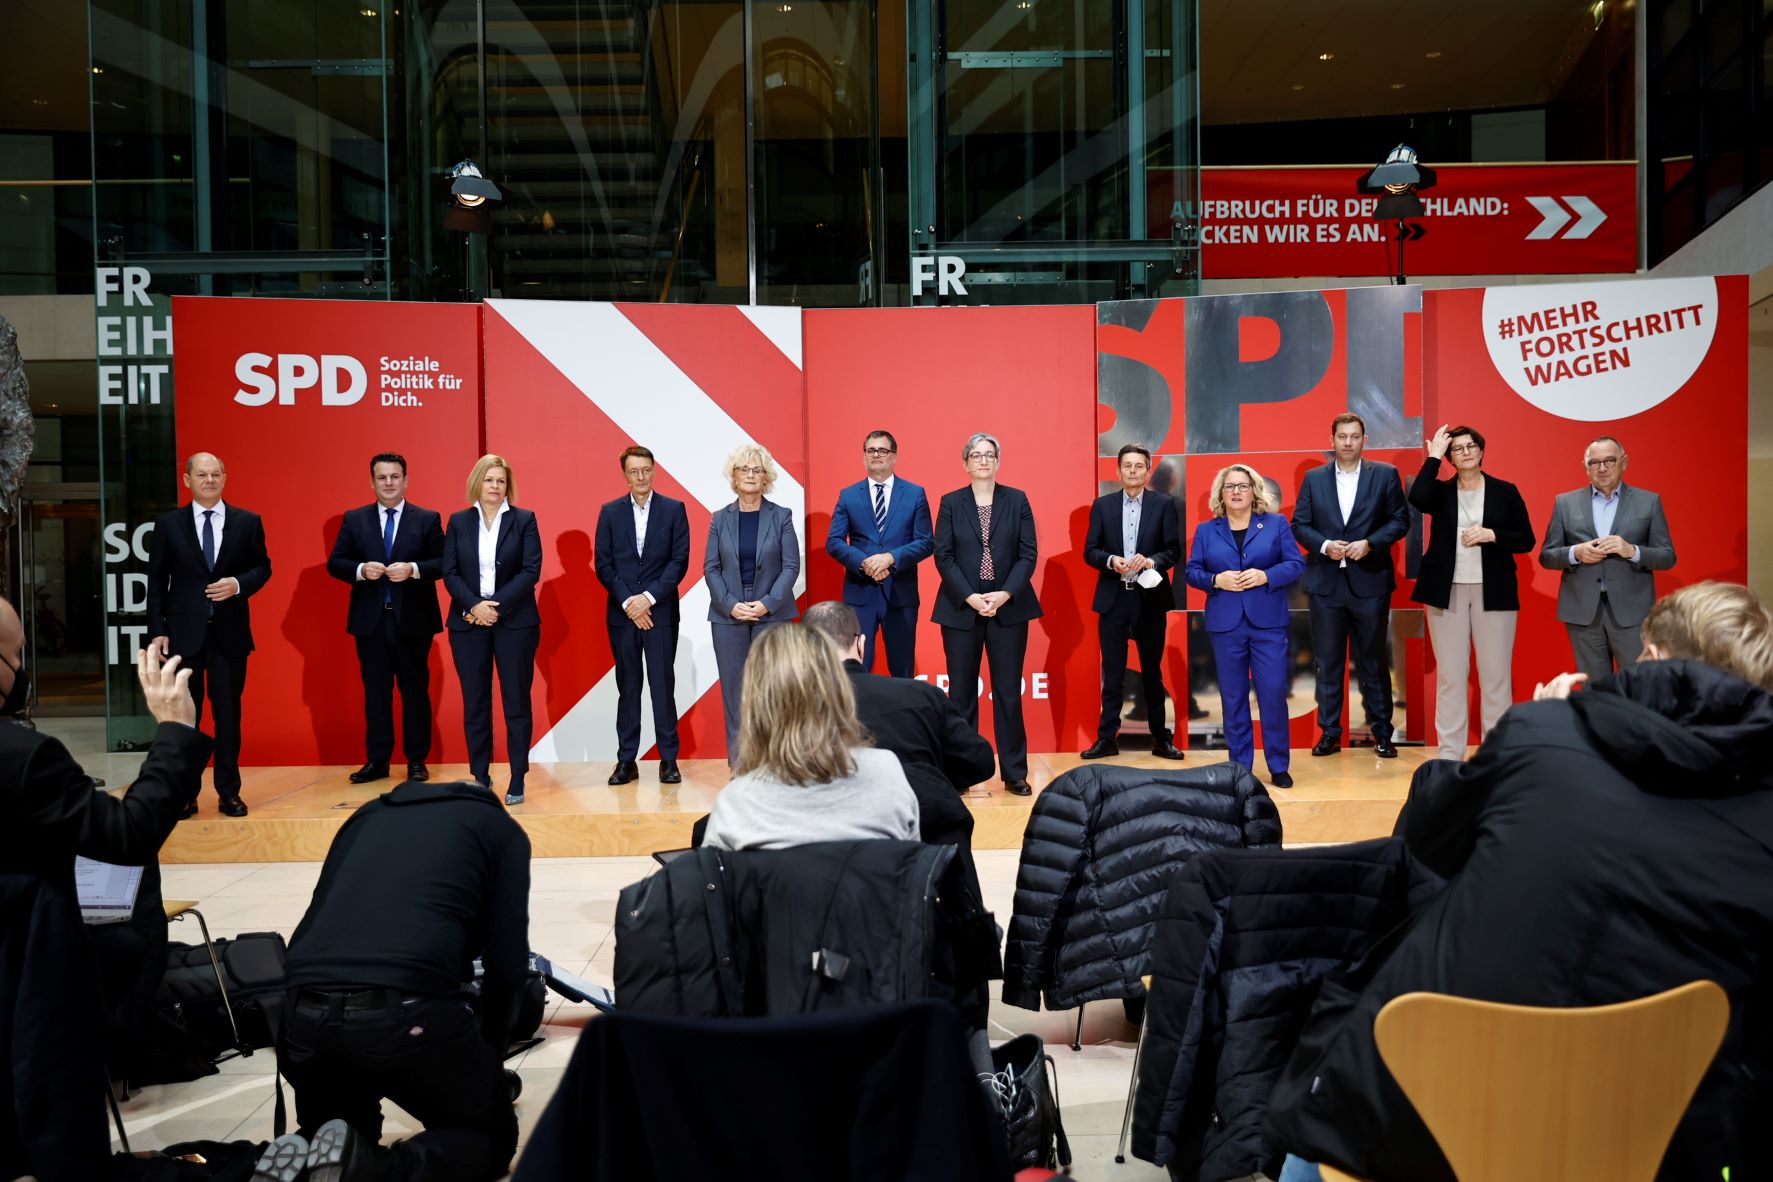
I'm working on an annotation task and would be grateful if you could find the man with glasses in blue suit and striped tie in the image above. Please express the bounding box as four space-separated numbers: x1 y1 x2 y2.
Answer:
824 431 934 677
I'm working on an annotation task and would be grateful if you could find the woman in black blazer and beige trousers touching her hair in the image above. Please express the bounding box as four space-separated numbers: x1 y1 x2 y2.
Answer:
1410 424 1534 758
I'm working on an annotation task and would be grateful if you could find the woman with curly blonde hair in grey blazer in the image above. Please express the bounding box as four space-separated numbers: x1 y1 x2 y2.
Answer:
702 443 800 764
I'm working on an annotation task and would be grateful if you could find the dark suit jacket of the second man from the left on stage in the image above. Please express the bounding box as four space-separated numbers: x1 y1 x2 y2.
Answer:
326 502 443 636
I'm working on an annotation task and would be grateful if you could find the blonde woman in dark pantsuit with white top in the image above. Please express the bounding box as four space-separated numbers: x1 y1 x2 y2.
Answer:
443 455 543 805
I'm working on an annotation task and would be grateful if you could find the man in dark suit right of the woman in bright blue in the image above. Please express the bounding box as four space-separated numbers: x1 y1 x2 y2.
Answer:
1293 415 1410 758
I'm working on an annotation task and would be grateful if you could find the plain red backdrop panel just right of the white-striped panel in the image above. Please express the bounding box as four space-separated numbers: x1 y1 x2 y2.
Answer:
807 305 1101 751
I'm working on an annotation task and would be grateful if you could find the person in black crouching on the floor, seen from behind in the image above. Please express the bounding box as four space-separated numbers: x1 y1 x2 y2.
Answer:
273 780 530 1182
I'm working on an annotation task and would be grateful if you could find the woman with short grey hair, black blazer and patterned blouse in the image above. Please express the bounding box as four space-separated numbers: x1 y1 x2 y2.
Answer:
929 434 1041 796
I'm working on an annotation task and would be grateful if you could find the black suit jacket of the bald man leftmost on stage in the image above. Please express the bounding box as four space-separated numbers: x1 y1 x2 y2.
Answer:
147 502 271 657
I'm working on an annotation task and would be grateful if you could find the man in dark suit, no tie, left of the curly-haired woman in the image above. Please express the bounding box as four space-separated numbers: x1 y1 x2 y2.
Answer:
596 447 690 783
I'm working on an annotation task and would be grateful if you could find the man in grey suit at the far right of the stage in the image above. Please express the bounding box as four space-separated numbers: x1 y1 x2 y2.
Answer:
1539 436 1674 679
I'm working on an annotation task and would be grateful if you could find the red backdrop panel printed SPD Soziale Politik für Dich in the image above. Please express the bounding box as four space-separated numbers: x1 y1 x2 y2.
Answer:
172 296 480 766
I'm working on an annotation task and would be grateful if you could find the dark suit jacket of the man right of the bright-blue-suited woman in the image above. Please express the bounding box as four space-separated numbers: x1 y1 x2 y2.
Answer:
1293 459 1410 595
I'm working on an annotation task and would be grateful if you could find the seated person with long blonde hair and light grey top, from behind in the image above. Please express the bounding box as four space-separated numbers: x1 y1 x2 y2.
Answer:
702 626 918 849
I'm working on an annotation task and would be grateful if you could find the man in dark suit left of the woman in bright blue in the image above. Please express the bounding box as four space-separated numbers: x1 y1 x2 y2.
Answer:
1083 443 1183 758
